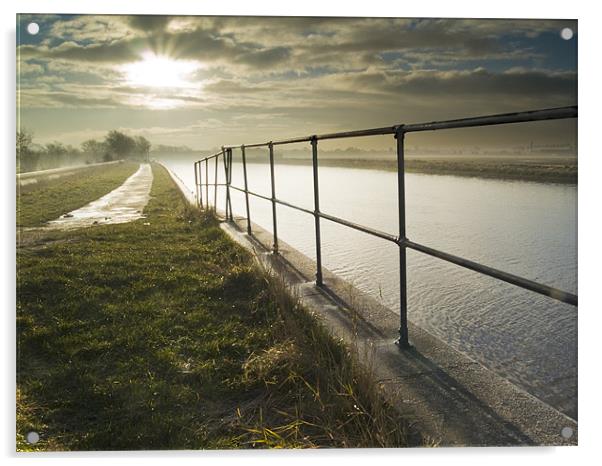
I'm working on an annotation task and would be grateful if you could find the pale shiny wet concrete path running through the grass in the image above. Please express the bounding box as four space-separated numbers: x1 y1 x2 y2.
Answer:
44 163 153 230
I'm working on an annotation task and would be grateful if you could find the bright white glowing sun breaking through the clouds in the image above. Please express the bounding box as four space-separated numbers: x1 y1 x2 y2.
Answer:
122 52 200 88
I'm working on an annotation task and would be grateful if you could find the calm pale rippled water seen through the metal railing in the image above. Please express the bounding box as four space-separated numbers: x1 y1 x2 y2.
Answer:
157 154 577 418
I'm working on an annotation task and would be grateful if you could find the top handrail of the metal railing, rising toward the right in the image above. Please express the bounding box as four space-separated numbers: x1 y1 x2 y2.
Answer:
212 106 577 153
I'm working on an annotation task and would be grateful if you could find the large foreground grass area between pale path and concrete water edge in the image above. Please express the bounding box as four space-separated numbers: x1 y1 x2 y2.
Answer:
17 166 420 450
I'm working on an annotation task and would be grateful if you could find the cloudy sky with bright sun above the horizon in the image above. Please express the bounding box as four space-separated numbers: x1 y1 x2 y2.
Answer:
17 15 578 149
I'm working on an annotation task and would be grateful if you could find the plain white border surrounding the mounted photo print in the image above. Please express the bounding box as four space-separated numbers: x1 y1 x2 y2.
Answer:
0 0 602 466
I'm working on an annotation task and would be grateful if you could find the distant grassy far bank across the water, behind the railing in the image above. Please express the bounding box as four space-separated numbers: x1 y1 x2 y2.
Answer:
270 157 577 184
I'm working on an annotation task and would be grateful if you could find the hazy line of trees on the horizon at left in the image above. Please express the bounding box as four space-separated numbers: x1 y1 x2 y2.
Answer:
17 130 151 172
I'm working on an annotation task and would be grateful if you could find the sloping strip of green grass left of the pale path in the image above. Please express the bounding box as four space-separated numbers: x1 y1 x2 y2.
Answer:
17 162 139 227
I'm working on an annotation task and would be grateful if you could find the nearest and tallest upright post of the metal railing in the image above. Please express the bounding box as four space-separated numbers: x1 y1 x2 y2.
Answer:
395 125 410 348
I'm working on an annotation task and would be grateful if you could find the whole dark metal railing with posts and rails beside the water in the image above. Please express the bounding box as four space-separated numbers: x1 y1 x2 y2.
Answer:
194 106 577 347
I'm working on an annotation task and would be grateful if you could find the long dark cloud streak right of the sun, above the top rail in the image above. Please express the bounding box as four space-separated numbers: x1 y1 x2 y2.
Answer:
204 69 577 106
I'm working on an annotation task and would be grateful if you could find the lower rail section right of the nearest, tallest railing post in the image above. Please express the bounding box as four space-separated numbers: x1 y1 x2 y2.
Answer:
400 239 577 306
